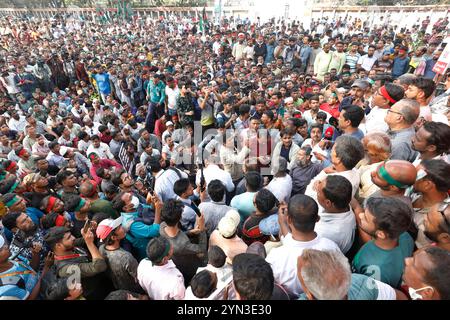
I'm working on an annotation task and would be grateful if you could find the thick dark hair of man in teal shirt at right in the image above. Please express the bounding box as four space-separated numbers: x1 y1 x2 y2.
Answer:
366 197 413 239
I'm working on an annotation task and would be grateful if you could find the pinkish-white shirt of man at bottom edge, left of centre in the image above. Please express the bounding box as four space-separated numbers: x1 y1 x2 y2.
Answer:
137 259 186 300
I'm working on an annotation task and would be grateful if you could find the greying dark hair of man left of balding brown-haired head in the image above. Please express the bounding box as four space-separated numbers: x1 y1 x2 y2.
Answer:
334 135 364 170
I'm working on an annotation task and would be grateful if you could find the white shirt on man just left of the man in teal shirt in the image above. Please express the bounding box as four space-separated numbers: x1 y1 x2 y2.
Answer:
314 209 356 254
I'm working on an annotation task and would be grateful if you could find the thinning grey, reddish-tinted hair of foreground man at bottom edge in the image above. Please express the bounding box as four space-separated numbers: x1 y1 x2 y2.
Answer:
300 249 352 300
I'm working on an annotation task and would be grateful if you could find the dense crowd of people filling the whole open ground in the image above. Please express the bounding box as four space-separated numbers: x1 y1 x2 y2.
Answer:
0 10 450 300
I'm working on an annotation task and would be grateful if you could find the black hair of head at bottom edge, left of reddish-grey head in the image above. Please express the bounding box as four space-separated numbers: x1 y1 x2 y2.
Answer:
233 253 274 300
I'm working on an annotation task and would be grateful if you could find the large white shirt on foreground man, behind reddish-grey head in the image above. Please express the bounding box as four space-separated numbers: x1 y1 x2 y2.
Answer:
266 233 339 296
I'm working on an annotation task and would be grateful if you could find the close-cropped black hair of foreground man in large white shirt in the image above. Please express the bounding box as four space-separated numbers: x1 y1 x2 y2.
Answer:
288 194 319 232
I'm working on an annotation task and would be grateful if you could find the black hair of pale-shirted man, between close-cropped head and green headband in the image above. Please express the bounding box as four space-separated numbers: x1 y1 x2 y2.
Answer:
322 175 353 209
